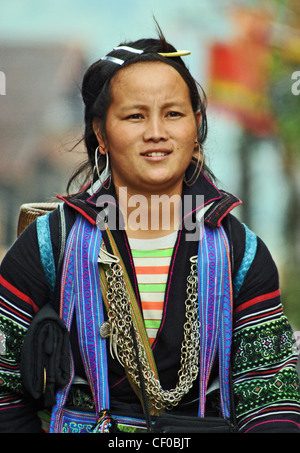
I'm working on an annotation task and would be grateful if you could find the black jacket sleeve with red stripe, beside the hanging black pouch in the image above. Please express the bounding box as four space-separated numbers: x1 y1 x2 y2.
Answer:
0 213 61 433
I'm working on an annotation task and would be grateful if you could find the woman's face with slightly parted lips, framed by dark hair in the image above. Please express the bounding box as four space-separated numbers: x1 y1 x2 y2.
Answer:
94 62 200 195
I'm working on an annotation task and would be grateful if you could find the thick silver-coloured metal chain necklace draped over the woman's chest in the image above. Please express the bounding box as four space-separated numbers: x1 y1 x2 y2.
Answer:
100 256 200 410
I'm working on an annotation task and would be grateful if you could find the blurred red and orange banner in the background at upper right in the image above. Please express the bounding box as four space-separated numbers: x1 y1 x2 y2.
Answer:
208 44 274 135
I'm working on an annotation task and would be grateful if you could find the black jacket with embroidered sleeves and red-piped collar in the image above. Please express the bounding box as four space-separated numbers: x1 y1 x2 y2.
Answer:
0 175 300 432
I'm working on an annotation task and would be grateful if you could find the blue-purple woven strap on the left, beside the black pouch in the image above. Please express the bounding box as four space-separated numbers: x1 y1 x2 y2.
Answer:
50 216 109 432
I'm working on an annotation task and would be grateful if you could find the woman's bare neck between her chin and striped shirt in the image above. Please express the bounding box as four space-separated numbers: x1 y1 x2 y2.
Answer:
117 185 182 239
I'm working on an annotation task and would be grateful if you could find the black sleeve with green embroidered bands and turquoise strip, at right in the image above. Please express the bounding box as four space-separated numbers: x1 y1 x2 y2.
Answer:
231 217 300 433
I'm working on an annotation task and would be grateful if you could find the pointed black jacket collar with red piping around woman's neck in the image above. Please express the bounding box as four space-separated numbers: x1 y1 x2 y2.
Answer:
58 168 241 227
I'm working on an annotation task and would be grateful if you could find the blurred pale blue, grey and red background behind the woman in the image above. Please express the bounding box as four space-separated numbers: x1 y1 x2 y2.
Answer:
0 0 300 324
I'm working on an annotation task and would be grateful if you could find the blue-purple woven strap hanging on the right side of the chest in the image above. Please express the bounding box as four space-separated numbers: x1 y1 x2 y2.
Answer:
198 226 232 418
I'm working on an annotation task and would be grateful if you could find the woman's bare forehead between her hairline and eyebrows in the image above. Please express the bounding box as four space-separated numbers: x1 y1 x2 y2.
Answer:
111 61 190 101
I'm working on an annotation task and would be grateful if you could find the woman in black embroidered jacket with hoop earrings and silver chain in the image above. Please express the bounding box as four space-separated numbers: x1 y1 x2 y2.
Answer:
0 30 300 432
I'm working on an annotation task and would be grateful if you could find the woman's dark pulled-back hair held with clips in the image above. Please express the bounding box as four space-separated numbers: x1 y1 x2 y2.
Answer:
68 26 213 189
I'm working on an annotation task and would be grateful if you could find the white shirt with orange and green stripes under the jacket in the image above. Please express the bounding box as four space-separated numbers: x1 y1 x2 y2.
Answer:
129 231 177 345
